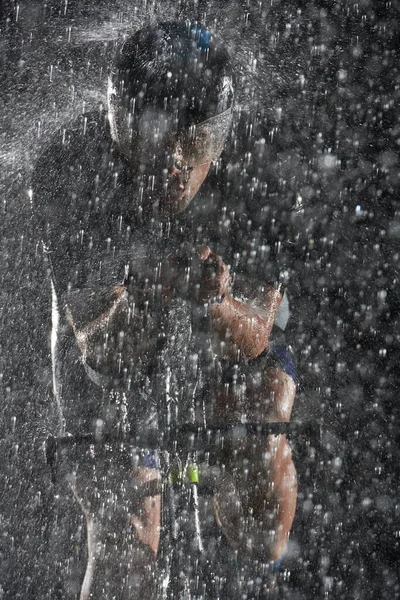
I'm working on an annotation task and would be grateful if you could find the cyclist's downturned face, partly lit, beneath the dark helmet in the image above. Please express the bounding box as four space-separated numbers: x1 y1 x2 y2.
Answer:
133 109 211 216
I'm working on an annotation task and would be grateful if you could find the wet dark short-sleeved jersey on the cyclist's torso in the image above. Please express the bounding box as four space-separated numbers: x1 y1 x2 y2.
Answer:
32 113 289 433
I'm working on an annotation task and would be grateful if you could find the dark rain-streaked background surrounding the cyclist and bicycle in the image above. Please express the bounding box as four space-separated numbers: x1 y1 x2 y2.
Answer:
0 0 400 600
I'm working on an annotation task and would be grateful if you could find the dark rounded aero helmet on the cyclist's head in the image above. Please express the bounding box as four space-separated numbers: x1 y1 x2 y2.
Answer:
109 22 233 162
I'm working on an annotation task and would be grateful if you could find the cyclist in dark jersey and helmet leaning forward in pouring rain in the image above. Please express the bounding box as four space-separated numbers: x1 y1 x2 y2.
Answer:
33 23 296 599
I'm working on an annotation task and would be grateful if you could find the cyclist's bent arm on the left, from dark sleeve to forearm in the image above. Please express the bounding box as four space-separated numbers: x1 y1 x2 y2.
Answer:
32 134 162 380
